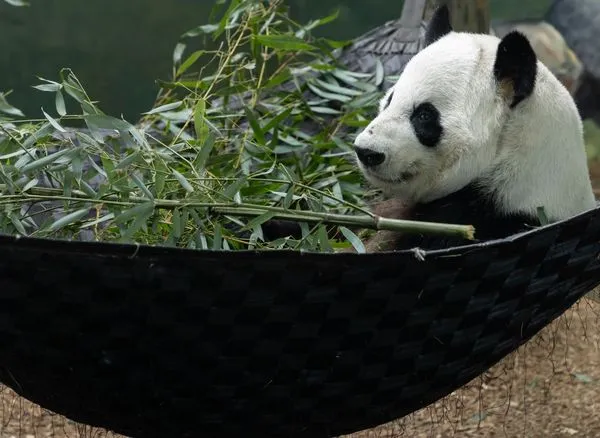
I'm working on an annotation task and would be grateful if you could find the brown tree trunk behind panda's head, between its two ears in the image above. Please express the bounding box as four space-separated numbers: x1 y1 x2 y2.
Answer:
424 0 490 33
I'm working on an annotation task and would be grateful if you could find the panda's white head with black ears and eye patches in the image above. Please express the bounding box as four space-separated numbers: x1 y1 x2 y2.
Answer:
354 6 539 202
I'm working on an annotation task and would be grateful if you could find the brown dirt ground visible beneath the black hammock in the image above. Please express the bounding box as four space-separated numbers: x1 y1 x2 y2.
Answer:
0 298 600 438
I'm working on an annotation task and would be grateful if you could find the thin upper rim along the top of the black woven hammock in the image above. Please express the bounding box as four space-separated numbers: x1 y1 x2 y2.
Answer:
0 203 600 259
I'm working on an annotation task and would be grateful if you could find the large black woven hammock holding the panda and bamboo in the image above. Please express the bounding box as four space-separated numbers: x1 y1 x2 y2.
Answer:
0 204 600 438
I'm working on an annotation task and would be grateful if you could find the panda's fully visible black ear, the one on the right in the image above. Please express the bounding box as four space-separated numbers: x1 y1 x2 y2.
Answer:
494 31 537 108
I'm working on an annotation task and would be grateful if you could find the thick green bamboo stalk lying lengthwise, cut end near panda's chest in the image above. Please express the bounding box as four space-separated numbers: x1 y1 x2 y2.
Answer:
0 184 475 240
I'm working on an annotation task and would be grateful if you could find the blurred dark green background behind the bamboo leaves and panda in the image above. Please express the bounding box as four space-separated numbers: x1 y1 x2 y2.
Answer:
0 0 551 122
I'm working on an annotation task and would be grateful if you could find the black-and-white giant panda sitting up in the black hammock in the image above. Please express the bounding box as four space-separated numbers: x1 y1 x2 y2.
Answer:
354 6 596 249
